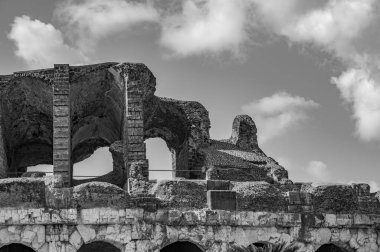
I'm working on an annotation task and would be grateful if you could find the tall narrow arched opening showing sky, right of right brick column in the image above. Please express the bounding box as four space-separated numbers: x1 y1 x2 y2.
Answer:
145 137 173 179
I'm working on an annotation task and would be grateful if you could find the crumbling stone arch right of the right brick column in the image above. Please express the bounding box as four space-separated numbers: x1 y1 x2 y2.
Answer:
144 96 210 179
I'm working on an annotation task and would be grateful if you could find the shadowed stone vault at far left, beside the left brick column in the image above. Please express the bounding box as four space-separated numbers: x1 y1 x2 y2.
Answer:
0 76 53 175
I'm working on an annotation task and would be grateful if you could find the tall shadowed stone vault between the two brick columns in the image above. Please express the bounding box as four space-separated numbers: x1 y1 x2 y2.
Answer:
70 68 126 187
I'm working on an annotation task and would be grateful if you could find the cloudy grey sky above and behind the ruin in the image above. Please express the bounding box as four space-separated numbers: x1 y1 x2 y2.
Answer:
0 0 380 191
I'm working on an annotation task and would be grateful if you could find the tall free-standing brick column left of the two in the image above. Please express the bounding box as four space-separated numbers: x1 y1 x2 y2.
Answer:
53 64 72 187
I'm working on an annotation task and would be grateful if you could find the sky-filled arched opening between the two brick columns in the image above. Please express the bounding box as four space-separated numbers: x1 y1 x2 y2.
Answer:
73 147 113 180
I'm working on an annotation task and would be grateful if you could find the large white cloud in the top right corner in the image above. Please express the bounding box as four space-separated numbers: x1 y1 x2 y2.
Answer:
252 0 375 63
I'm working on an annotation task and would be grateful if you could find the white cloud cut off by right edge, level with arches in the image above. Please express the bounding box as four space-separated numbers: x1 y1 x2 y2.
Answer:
332 69 380 141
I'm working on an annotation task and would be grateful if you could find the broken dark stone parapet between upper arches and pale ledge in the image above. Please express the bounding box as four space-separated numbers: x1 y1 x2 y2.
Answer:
0 177 380 214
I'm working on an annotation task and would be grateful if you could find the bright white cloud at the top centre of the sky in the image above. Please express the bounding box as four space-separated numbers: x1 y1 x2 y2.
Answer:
160 0 248 56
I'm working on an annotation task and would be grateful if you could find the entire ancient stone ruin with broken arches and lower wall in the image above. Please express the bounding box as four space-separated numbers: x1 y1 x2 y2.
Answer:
0 63 380 252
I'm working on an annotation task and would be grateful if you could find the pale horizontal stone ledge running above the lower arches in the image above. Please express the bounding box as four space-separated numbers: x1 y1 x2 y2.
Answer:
0 208 380 228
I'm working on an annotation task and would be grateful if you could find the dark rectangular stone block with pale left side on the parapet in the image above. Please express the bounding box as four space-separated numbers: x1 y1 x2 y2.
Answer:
207 190 236 210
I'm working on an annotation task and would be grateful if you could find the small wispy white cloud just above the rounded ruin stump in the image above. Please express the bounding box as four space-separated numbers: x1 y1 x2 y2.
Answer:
242 92 319 143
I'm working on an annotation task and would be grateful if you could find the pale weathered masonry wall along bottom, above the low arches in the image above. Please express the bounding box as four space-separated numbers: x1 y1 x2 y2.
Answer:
0 208 380 252
